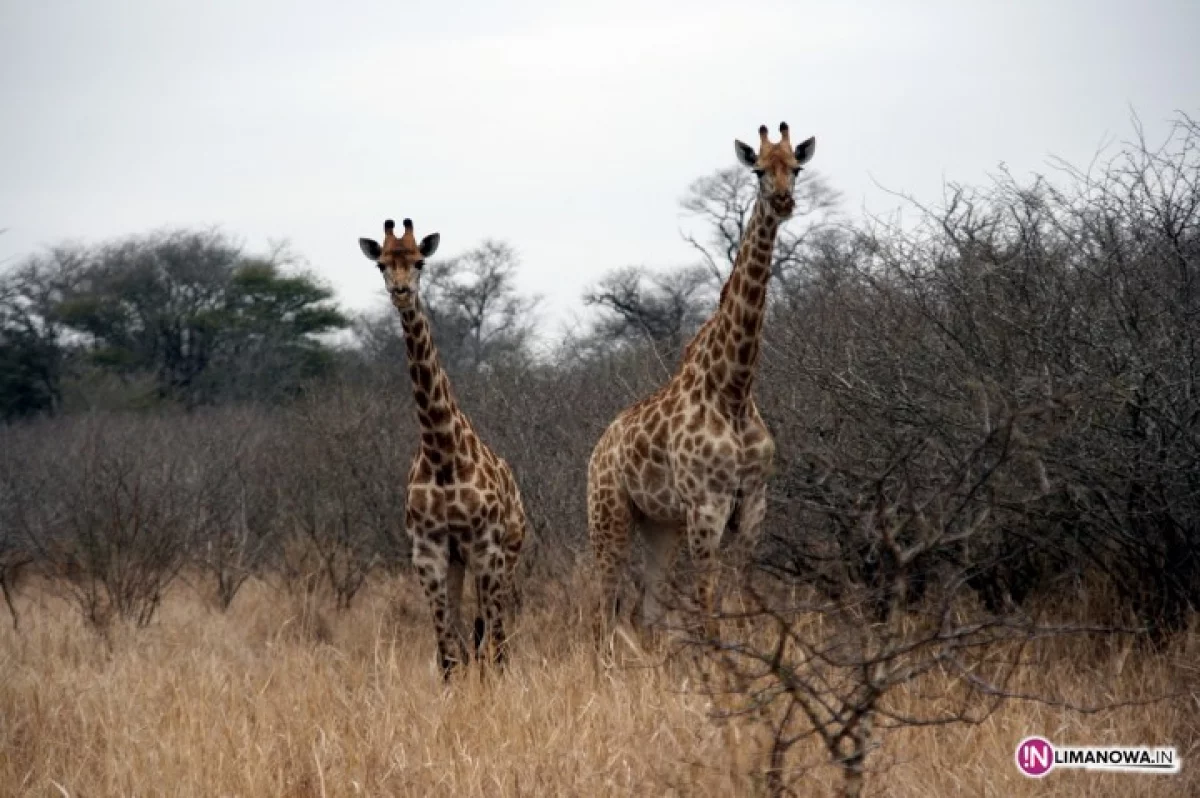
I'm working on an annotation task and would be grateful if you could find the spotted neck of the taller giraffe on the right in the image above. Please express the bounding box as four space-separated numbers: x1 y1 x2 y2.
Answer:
690 197 780 403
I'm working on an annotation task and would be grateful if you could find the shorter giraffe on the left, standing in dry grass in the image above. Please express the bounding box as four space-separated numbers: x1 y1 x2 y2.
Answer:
359 218 527 679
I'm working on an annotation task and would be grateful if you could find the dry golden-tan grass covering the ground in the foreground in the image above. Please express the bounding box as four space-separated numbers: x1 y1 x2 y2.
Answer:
0 580 1200 798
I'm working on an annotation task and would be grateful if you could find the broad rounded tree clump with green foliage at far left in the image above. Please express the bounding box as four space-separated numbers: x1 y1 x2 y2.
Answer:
0 225 348 408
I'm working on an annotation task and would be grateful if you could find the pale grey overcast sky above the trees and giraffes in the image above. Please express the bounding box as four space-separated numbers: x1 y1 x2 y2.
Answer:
0 0 1200 329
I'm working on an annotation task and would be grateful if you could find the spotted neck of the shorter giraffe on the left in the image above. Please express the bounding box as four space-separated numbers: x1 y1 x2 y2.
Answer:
400 301 463 467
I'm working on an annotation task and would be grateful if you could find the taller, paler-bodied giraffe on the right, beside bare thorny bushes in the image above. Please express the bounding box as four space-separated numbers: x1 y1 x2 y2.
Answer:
588 122 816 635
